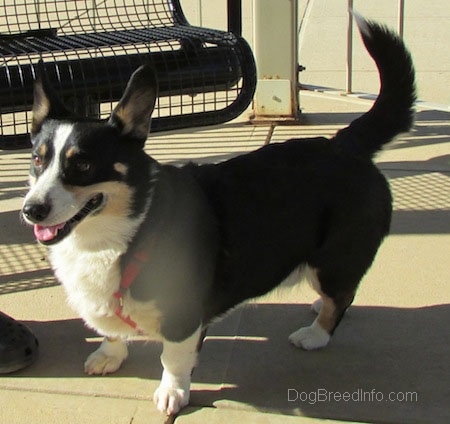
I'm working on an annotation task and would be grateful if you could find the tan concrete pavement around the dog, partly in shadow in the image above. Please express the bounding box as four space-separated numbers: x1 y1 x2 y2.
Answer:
0 92 450 424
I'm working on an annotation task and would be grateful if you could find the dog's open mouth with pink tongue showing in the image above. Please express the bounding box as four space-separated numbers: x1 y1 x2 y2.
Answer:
34 193 103 245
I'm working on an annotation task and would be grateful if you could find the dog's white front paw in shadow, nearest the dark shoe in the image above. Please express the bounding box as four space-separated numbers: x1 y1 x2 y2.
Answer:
84 339 128 375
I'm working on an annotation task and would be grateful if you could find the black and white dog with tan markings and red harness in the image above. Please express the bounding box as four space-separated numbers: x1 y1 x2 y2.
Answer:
22 14 415 415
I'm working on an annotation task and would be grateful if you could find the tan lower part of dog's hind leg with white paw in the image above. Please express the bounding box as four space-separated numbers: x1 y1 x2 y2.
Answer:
289 269 357 350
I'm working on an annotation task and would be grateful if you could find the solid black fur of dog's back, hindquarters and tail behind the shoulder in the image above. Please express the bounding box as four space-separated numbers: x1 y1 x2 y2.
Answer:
139 17 415 342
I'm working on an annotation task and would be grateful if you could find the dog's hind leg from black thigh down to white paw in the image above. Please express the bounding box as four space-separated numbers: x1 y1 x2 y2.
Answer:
289 211 390 350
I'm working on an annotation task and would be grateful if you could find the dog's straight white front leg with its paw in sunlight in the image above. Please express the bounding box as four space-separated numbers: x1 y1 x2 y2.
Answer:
153 327 201 415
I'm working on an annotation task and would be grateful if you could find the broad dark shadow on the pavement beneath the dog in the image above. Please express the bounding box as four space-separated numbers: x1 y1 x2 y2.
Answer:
10 304 450 422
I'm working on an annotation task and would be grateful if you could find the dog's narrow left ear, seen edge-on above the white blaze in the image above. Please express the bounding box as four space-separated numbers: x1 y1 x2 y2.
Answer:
31 59 70 134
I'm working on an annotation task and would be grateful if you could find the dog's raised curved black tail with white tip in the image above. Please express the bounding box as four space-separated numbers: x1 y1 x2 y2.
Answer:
334 13 416 157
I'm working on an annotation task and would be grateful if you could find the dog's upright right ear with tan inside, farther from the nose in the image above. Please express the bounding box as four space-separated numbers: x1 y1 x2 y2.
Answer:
108 65 158 145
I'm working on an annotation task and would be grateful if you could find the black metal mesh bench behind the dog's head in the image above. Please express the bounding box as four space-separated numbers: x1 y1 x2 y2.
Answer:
0 0 256 149
